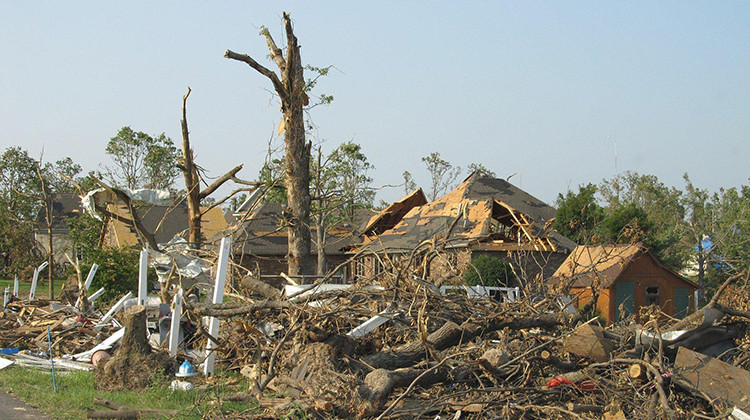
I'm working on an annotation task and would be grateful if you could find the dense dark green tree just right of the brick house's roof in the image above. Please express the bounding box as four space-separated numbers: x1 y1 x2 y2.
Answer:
553 184 604 244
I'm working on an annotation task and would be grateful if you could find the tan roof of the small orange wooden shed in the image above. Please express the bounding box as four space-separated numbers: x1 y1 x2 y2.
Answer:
549 244 696 288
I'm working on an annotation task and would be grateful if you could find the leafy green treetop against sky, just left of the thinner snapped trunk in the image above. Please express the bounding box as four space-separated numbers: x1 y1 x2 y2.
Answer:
105 127 180 189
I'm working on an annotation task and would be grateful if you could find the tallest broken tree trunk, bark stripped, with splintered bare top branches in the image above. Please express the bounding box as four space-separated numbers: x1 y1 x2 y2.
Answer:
224 13 313 275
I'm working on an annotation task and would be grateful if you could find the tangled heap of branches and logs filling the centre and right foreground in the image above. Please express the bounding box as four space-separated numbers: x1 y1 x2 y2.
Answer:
197 268 750 419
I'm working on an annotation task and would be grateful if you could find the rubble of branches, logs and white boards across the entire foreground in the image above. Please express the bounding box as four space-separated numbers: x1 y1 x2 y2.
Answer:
0 245 750 419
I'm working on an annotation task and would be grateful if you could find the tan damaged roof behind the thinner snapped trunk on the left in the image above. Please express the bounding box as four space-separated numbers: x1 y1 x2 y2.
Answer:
107 204 227 247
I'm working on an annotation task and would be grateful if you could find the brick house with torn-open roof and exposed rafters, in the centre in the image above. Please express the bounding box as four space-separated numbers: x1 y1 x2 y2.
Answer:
351 172 576 284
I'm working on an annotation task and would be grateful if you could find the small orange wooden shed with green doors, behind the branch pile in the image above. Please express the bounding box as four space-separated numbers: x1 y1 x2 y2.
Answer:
550 244 698 322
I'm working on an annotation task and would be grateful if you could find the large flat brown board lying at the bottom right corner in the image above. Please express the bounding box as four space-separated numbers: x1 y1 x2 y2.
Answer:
674 347 750 411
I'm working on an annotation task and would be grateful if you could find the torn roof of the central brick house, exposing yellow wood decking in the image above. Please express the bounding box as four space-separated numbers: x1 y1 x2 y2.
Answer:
356 172 575 252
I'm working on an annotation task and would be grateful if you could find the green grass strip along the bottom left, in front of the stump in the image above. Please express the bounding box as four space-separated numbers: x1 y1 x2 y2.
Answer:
0 366 252 419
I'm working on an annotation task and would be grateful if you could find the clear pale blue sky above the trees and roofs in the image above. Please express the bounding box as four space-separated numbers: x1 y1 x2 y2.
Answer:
0 1 750 202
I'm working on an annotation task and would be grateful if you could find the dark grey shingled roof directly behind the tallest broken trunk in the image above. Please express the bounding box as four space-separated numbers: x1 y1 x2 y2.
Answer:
234 201 369 256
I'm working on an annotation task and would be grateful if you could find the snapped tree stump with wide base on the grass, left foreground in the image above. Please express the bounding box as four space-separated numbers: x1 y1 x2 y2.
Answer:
95 305 176 391
